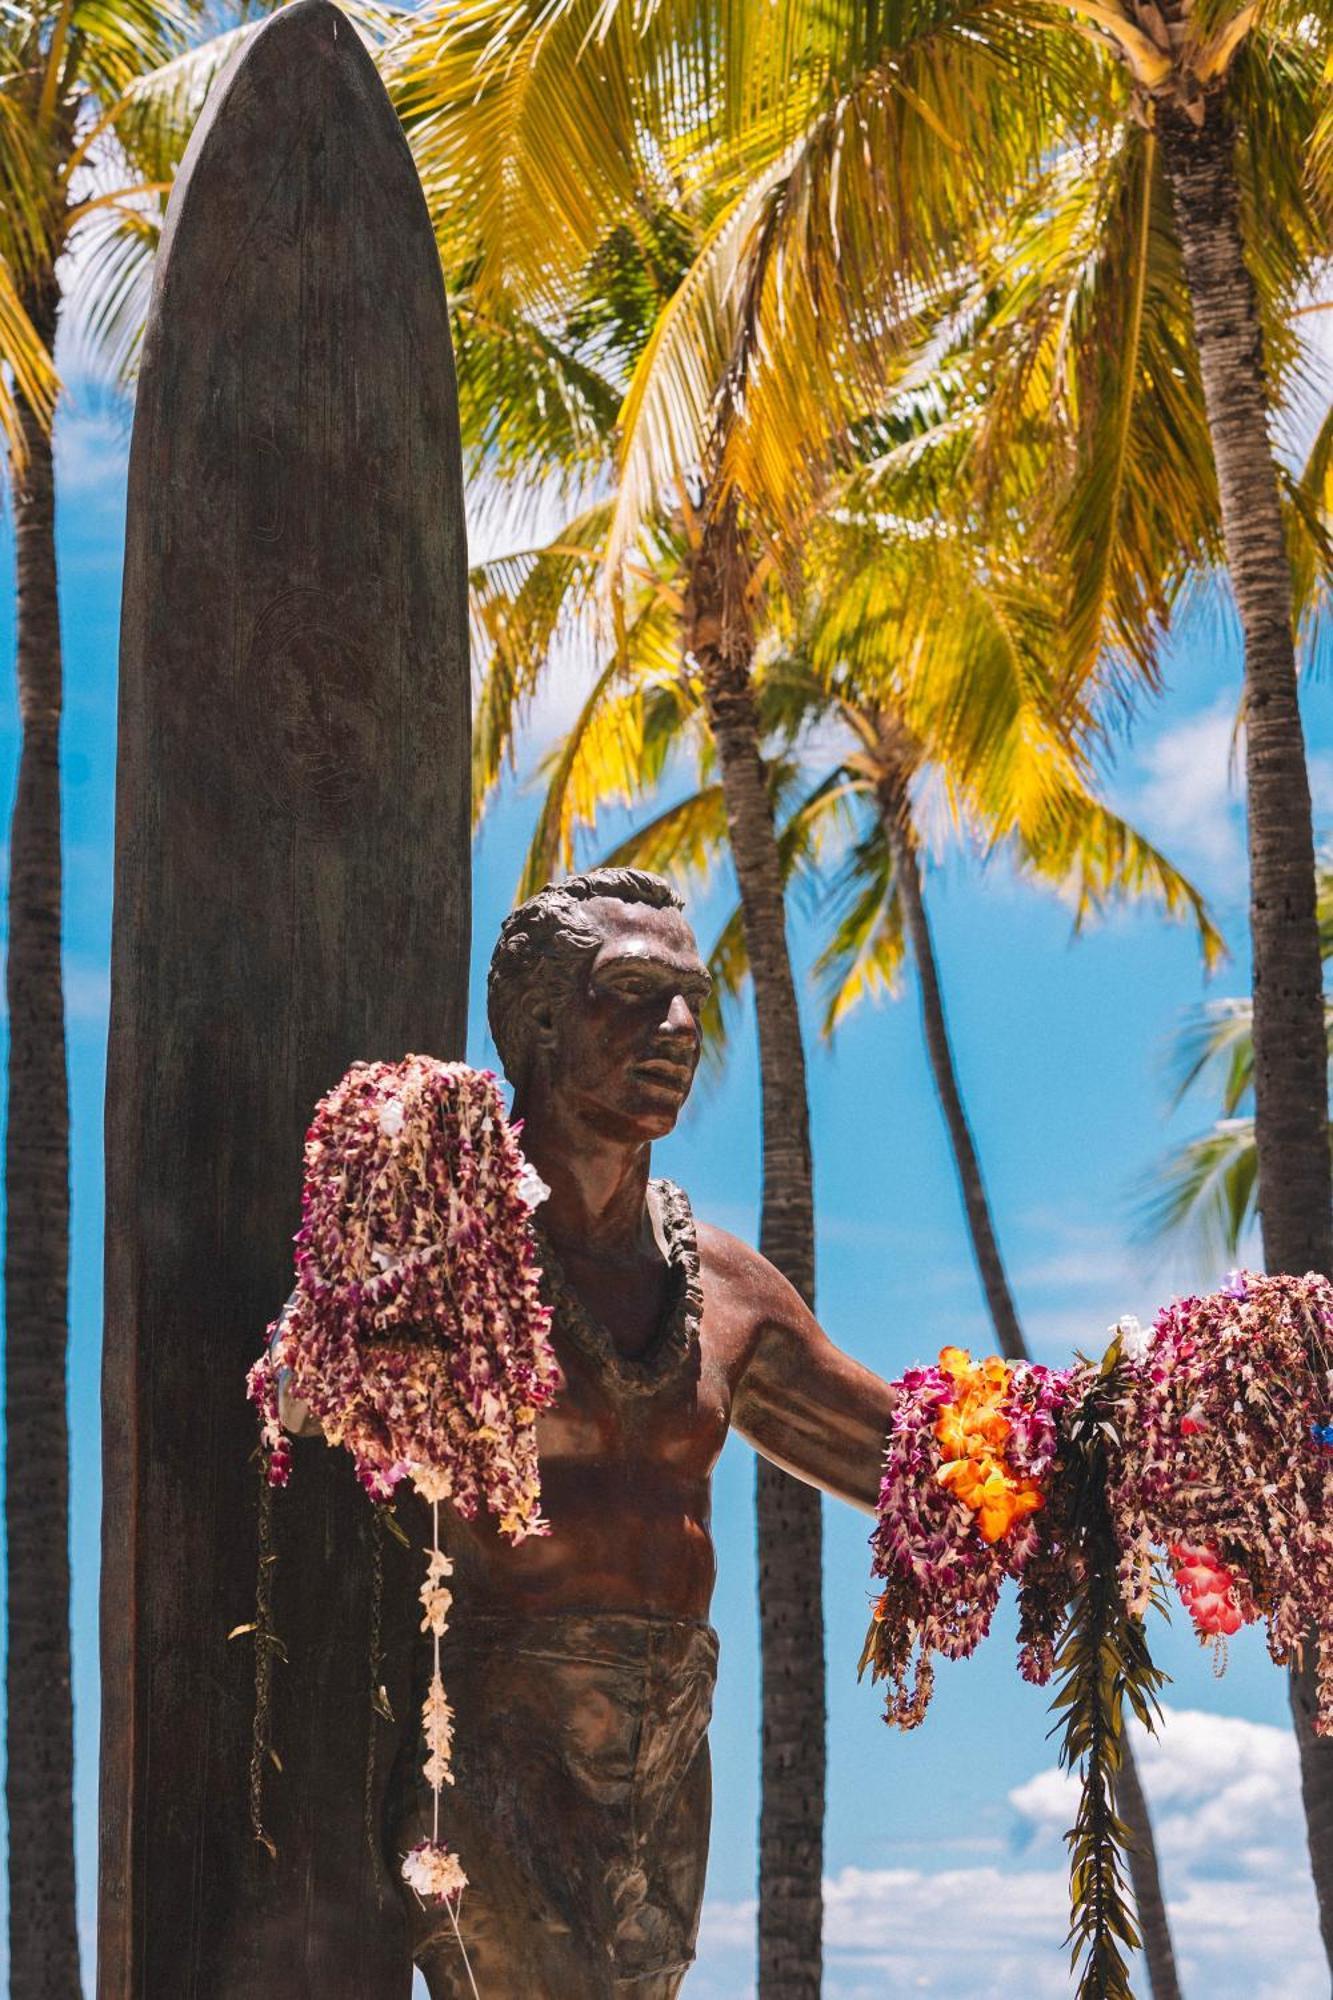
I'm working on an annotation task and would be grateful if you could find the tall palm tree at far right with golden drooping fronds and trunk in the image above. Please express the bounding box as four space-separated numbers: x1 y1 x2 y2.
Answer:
460 0 1333 1958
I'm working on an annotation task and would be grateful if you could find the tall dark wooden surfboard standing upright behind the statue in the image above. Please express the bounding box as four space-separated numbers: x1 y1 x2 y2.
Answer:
98 0 470 2000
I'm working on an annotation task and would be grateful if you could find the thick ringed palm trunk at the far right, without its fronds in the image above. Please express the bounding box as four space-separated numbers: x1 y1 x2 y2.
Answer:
1159 98 1333 1964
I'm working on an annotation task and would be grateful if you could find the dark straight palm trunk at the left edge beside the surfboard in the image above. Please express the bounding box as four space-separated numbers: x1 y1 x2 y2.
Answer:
4 284 80 2000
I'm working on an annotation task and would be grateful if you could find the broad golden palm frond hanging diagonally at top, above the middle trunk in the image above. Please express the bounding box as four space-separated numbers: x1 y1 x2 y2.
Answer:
725 0 1103 534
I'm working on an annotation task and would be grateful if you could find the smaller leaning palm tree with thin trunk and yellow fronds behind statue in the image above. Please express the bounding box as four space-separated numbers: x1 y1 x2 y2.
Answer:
476 458 1200 2000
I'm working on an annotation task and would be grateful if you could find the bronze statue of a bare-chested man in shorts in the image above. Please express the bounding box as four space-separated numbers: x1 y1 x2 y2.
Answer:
290 868 893 2000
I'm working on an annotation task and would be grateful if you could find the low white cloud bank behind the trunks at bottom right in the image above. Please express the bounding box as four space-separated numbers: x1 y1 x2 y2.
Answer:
685 1710 1327 2000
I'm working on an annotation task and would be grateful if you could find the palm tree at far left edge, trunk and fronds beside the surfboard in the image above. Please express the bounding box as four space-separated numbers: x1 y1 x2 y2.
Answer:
0 11 298 2000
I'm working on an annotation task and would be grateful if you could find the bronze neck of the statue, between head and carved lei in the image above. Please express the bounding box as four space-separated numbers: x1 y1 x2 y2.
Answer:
514 1094 652 1258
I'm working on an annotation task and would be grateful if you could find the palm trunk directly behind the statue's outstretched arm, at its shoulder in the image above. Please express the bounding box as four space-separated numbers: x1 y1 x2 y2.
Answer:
687 512 825 2000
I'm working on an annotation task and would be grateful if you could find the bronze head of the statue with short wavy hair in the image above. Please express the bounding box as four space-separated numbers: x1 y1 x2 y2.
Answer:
486 868 709 1138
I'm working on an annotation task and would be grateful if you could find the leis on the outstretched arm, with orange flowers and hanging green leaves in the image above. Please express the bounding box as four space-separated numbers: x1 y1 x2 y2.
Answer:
861 1272 1333 2000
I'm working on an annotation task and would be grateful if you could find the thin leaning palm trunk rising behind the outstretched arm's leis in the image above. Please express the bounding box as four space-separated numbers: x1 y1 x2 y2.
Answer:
879 780 1181 2000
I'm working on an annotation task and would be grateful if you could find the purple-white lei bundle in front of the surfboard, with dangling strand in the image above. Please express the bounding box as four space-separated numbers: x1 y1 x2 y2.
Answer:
246 1056 560 1908
